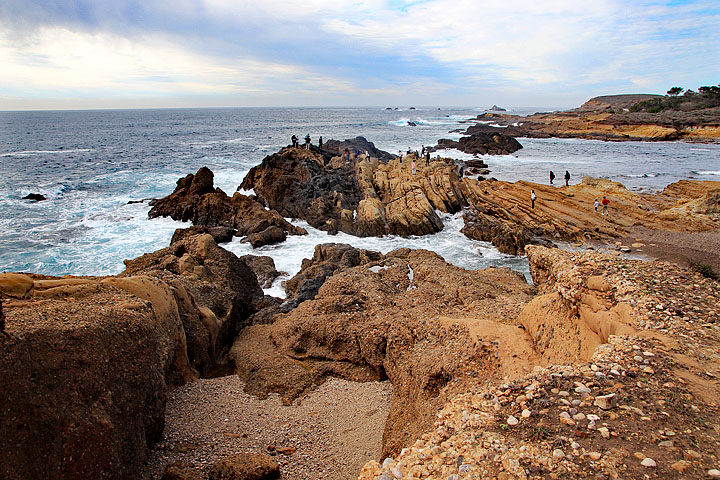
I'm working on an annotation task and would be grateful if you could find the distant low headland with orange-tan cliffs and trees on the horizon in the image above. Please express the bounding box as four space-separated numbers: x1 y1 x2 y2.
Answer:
467 86 720 141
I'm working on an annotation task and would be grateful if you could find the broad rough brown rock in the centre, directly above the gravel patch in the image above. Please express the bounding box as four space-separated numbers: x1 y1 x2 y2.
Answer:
230 245 533 453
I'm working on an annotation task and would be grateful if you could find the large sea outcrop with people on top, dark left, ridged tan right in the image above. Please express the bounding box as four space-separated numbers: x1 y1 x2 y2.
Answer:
241 148 465 236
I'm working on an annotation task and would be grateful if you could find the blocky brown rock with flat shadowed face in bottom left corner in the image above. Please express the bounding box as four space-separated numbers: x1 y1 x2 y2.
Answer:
0 274 194 479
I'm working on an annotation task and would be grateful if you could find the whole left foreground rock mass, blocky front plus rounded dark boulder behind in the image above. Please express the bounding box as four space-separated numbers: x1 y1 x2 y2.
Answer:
0 235 262 479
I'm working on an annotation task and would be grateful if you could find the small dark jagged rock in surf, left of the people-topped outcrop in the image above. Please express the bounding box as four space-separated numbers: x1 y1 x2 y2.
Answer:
148 167 307 244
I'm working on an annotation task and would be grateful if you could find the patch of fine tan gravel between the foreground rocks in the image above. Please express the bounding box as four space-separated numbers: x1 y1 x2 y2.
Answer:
143 375 392 480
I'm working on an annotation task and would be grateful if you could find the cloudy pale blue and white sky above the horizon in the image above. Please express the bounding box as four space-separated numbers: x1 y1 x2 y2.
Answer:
0 0 720 110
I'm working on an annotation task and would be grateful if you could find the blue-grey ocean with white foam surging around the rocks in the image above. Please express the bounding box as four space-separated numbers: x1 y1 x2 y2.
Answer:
0 107 720 295
